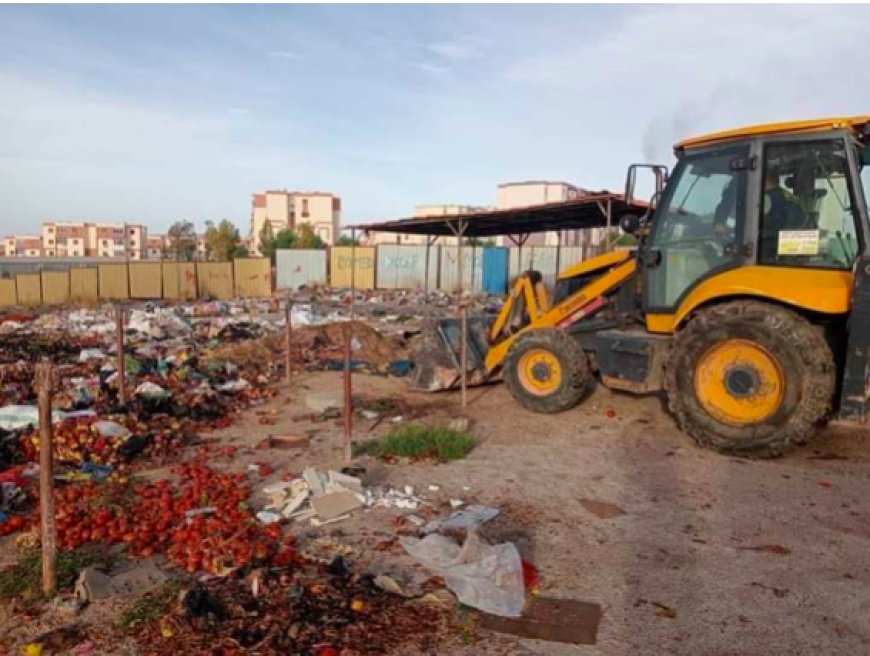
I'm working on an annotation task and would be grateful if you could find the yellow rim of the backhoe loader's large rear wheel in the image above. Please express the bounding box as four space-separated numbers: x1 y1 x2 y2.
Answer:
695 339 785 426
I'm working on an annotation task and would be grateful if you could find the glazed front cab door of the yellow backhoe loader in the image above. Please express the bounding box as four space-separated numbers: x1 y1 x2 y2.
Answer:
643 145 751 314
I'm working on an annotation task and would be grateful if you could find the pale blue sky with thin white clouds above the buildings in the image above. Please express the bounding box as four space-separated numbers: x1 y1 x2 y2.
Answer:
0 5 870 234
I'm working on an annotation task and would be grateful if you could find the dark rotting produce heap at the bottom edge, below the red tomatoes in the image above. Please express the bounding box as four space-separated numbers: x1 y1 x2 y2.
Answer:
134 556 456 656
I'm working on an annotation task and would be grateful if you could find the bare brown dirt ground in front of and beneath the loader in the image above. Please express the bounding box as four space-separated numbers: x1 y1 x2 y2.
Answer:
186 373 870 656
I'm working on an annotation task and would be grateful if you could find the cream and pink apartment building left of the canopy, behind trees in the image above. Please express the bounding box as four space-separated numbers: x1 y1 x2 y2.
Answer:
249 189 341 252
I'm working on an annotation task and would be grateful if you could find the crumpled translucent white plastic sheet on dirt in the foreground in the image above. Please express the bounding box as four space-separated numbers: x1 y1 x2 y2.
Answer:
400 526 525 617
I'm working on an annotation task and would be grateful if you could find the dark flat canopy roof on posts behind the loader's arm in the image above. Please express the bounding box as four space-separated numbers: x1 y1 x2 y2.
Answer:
347 191 648 237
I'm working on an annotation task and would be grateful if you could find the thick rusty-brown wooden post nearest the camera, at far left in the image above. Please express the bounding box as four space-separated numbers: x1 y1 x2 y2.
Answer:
34 358 57 597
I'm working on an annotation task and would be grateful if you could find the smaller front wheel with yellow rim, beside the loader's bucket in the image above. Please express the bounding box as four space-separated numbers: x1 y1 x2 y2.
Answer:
504 328 592 414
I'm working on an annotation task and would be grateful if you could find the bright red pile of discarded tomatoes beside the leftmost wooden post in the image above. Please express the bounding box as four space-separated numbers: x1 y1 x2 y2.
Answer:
49 463 293 574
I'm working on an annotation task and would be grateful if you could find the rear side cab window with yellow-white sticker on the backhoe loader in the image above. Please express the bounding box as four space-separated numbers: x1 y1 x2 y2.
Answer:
758 139 859 269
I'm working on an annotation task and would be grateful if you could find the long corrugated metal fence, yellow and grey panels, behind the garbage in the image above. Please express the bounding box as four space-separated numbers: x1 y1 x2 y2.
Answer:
0 244 602 307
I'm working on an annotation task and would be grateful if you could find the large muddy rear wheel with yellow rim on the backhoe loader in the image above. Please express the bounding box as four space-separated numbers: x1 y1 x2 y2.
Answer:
665 301 836 458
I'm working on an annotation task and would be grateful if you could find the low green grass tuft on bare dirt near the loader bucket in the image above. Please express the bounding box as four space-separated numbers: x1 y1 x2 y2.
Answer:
354 424 477 462
